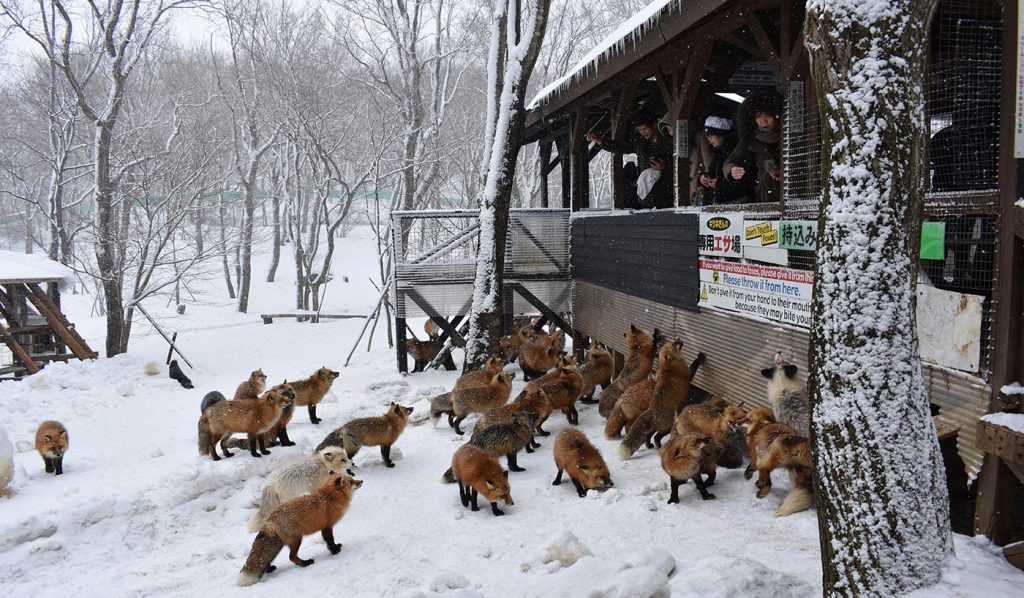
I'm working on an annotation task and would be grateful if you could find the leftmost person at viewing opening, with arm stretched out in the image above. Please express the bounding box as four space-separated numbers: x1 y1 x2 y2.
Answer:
587 111 676 209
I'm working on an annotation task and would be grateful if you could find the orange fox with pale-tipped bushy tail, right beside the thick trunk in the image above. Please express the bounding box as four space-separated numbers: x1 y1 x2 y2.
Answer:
743 408 814 517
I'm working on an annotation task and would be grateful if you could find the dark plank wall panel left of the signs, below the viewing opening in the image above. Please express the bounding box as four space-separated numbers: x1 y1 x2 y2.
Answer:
569 212 700 311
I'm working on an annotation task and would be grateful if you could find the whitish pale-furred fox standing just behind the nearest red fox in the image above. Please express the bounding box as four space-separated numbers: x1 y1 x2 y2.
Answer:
249 446 354 532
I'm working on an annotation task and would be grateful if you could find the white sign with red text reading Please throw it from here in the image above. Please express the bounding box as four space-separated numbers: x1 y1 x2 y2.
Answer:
697 259 814 328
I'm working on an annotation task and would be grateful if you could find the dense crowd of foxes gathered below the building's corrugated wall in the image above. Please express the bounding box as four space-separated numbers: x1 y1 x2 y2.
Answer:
421 319 813 516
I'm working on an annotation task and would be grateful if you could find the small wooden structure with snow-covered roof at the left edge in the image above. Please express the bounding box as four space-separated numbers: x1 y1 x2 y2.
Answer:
0 251 96 380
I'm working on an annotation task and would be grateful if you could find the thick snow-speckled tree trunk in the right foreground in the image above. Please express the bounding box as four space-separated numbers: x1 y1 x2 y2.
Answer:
805 0 952 596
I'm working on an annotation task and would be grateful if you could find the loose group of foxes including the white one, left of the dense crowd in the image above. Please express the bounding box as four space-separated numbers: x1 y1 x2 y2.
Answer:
192 368 413 586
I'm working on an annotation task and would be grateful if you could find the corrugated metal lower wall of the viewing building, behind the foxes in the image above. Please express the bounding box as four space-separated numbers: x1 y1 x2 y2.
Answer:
572 281 991 477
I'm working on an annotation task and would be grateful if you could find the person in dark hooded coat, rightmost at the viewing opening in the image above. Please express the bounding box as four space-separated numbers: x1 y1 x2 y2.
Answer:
723 92 782 202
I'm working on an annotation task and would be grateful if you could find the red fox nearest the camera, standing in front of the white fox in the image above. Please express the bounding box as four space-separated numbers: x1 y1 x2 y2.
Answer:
238 473 362 586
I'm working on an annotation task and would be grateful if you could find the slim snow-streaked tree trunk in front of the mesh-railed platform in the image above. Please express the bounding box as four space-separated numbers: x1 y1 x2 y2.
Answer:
465 0 550 371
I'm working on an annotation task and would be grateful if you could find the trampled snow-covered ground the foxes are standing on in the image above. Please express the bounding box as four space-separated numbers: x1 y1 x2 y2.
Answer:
0 229 1024 597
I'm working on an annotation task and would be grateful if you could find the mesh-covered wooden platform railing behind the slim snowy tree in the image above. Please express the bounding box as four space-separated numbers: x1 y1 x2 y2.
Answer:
392 209 569 317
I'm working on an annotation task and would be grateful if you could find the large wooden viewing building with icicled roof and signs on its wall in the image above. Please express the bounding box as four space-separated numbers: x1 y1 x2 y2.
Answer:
527 0 1024 543
